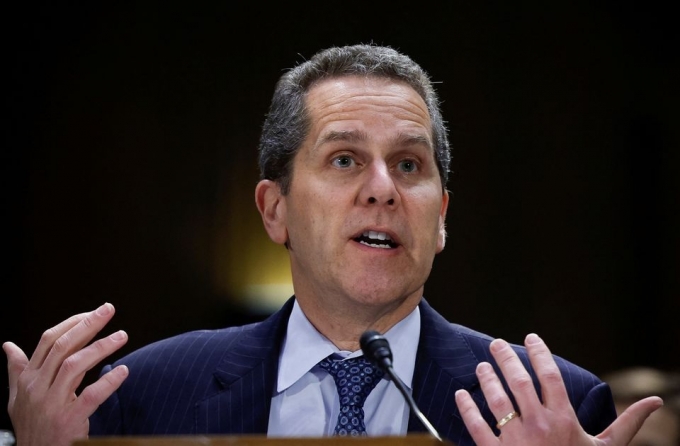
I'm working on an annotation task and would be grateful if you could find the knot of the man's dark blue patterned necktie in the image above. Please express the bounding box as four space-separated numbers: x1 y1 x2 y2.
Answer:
319 356 384 407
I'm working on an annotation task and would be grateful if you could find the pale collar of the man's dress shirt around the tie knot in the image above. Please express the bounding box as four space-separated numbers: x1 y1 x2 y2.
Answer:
277 300 420 392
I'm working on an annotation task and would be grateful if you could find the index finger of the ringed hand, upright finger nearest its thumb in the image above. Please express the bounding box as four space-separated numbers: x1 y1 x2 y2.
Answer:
524 333 573 411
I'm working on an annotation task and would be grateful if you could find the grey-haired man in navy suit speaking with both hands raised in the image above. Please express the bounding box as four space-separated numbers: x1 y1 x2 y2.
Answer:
4 45 661 446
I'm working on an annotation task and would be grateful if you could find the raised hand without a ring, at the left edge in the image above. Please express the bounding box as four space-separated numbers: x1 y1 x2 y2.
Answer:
2 303 129 446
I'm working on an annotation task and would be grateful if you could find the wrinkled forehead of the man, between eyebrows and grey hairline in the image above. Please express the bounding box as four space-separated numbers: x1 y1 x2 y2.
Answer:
306 75 432 139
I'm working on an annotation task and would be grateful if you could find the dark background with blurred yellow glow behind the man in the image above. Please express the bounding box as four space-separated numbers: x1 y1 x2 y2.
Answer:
0 0 680 428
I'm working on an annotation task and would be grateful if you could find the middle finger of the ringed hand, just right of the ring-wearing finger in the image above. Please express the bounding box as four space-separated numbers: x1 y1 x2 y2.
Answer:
490 339 541 416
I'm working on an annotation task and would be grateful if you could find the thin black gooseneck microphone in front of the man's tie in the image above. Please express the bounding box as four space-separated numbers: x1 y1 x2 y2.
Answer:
359 330 443 441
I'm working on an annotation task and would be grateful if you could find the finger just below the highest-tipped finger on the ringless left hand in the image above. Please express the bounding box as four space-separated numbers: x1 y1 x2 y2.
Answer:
54 330 128 398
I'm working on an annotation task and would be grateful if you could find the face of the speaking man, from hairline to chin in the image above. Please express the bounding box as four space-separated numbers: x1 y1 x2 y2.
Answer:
255 76 448 314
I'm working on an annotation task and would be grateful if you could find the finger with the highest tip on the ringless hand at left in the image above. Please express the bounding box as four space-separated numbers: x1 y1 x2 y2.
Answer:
41 303 115 386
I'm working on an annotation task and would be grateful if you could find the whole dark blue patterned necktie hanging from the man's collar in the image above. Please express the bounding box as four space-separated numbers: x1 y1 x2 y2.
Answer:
319 355 384 437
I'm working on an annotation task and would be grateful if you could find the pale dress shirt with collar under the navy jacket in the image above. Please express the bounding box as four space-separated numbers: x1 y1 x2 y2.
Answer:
267 301 420 437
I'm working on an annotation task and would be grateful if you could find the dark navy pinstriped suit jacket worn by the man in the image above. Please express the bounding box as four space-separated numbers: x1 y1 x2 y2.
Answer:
90 298 616 446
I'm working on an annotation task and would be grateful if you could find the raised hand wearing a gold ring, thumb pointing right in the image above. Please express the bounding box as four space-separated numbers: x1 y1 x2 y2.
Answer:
456 334 663 446
